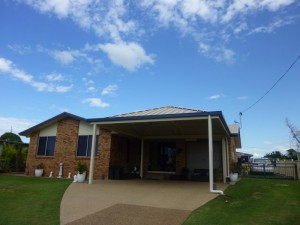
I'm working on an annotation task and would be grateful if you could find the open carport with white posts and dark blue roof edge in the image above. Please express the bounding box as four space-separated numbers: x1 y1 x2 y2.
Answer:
88 107 239 194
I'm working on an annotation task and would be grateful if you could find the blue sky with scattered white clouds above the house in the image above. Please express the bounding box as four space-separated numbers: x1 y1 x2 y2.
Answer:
0 0 300 156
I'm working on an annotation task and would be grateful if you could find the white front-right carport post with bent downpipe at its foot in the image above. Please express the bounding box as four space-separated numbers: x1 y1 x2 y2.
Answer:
208 115 224 195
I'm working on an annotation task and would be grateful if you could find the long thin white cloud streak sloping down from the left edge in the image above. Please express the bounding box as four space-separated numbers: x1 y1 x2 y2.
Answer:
0 58 72 93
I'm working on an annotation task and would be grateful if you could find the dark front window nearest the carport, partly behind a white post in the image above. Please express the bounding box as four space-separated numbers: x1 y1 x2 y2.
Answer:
77 135 99 156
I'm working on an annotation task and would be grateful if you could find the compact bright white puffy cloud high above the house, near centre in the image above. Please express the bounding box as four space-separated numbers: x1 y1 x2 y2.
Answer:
99 42 154 71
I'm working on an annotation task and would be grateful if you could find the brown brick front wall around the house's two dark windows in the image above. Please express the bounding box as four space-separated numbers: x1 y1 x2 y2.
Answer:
26 118 106 179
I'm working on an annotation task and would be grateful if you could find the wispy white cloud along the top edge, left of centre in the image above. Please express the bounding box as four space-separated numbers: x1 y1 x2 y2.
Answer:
22 0 136 41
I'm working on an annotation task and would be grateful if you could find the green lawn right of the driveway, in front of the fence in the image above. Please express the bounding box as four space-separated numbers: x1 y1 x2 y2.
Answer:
184 178 300 225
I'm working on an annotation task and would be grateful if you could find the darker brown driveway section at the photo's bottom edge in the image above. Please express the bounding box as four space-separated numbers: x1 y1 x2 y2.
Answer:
67 204 191 225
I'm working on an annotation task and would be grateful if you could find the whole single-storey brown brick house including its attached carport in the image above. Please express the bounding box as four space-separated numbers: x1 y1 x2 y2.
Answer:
20 107 241 190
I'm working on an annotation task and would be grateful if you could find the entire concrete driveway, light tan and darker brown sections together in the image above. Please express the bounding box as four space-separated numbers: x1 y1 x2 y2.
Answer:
60 180 227 225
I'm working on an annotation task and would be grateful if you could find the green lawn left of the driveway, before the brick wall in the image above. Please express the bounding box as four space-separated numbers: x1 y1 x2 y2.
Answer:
0 175 71 225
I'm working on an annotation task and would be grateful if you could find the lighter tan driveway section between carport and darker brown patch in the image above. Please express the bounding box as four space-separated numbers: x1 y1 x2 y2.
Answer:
60 180 227 225
